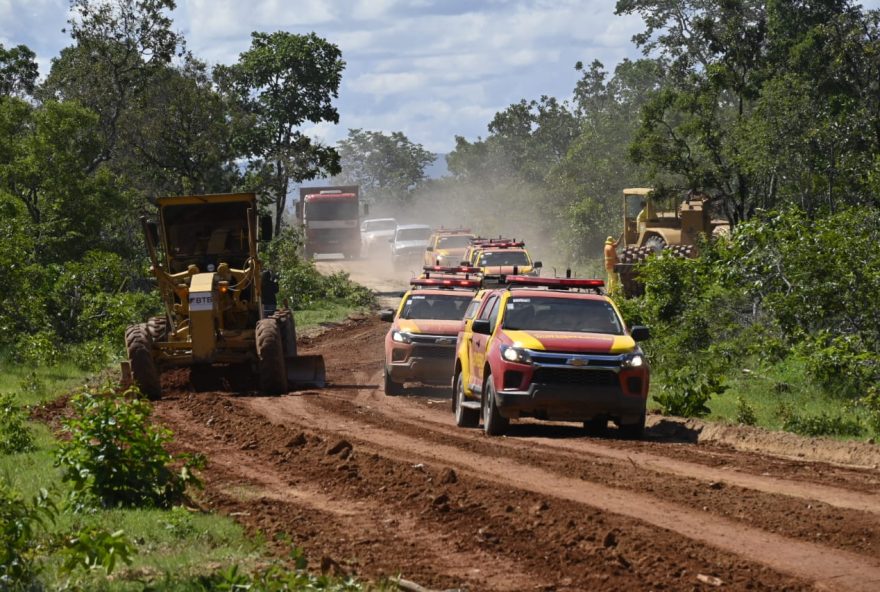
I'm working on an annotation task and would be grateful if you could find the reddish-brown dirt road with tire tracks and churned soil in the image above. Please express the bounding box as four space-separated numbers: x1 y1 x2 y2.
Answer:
156 262 880 591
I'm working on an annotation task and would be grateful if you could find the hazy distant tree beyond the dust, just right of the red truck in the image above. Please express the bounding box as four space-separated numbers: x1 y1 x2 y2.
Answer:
335 129 436 205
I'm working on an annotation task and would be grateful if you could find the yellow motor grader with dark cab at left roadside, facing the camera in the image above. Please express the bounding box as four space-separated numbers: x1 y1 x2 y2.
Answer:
123 193 325 399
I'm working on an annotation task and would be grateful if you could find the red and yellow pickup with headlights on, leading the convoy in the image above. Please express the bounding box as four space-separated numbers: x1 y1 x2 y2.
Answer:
452 275 649 437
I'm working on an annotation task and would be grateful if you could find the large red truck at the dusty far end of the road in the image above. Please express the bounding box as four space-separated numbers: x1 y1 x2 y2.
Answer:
296 185 369 259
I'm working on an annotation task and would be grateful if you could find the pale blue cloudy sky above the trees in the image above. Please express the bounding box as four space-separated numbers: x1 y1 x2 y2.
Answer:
0 0 880 152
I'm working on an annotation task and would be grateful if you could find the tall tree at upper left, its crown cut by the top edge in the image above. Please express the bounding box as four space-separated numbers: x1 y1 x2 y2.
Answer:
41 0 183 171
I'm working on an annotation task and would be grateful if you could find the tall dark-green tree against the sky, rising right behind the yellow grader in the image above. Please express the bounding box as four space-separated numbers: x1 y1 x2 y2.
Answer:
214 31 345 233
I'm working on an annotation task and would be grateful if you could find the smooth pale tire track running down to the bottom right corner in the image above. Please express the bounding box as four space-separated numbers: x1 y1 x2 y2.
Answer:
249 388 880 592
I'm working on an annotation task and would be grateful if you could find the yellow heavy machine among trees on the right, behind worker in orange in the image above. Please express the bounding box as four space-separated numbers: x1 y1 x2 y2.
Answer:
614 187 729 296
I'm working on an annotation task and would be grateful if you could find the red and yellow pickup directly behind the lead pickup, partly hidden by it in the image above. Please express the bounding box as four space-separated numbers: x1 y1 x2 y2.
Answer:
380 268 480 395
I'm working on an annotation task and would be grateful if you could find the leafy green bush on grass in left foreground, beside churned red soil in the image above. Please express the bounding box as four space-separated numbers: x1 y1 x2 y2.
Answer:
56 386 204 507
